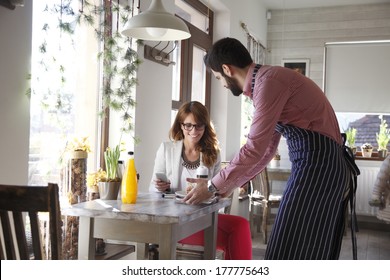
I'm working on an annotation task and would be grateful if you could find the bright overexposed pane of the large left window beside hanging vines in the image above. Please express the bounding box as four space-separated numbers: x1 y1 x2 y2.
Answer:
29 0 99 184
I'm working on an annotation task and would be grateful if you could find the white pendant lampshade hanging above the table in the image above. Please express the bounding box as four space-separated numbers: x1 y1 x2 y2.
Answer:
122 0 191 41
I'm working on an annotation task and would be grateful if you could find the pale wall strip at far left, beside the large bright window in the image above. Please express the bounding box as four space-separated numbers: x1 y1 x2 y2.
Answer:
0 1 32 185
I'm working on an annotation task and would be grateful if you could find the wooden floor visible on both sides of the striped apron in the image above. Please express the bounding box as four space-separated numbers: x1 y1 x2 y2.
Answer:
252 220 390 260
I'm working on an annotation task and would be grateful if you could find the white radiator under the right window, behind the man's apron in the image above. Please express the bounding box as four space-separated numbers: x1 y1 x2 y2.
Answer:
356 167 379 216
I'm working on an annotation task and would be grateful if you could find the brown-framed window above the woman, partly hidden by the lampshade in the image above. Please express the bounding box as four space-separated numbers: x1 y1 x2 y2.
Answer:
172 0 213 117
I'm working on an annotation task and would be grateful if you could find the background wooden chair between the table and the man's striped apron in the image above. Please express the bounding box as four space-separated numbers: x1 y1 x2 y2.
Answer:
249 168 282 244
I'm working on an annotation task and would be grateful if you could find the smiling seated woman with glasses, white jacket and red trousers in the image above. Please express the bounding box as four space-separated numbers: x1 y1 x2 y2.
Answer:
150 101 252 260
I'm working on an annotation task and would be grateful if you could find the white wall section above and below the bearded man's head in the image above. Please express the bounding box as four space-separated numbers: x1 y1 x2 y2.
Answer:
211 0 267 163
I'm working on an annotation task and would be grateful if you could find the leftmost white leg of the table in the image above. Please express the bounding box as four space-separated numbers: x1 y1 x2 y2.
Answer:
78 216 95 260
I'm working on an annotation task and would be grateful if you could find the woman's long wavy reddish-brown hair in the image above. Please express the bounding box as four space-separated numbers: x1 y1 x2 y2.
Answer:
169 101 219 167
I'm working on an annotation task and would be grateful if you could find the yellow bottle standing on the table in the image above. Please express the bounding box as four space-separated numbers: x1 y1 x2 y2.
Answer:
121 152 138 204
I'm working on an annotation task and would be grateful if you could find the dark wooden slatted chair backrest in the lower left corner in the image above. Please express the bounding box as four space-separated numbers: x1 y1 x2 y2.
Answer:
0 184 62 260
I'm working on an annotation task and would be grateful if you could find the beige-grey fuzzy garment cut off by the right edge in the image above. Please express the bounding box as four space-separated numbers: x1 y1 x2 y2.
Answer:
369 155 390 223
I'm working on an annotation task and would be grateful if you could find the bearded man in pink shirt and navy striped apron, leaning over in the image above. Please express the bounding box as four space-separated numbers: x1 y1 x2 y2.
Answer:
185 38 353 259
